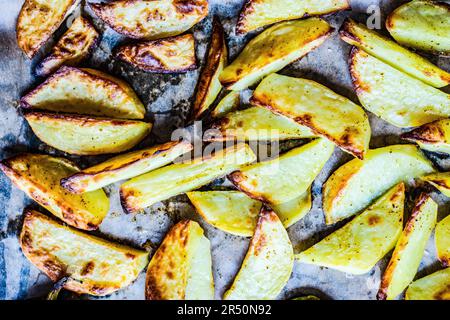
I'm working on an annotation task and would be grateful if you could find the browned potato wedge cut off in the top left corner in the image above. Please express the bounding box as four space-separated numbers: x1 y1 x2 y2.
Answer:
16 0 81 58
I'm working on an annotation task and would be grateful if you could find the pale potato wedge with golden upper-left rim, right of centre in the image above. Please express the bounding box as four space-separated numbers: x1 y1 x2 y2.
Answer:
322 145 434 224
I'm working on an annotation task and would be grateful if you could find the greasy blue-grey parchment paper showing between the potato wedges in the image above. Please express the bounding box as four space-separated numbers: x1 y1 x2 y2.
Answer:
0 0 450 299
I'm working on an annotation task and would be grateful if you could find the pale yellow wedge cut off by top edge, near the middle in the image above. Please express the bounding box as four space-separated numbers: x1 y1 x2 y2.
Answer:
236 0 350 34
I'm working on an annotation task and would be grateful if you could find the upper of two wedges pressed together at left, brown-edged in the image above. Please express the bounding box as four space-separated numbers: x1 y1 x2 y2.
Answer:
20 66 145 119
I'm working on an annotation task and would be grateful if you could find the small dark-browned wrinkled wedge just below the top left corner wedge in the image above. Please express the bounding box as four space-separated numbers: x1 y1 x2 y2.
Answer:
36 16 99 77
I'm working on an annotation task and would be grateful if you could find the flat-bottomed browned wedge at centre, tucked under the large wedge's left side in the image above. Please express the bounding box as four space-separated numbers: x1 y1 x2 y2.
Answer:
204 107 314 141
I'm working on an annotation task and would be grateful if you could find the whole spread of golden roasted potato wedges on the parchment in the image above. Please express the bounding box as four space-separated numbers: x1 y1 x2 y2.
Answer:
0 0 450 300
